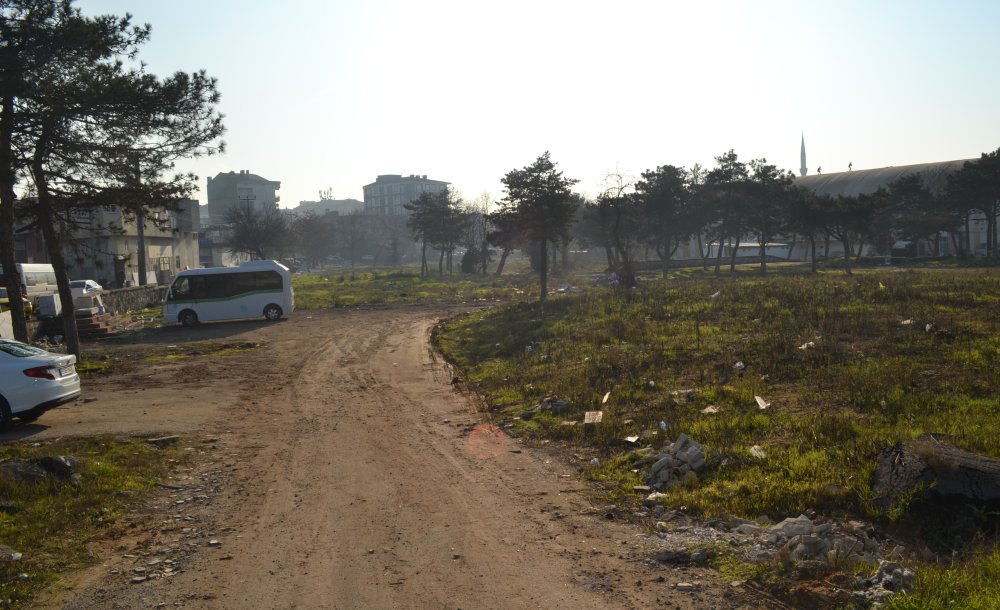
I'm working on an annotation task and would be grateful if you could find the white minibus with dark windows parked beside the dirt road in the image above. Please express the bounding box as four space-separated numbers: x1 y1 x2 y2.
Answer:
163 261 295 326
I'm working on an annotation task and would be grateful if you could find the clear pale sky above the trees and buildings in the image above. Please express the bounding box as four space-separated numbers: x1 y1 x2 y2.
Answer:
76 0 1000 207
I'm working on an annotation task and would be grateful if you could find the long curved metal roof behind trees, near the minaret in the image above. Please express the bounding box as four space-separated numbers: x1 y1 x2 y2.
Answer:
795 159 977 197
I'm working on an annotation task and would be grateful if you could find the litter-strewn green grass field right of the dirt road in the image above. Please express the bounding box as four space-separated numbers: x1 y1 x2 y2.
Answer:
438 269 1000 608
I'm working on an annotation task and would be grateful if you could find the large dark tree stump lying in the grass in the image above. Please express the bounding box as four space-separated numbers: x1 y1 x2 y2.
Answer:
872 435 1000 510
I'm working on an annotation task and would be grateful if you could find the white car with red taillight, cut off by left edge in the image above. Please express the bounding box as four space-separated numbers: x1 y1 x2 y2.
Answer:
0 339 80 432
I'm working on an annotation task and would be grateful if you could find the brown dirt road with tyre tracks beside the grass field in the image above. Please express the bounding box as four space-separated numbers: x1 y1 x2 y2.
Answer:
20 306 768 609
